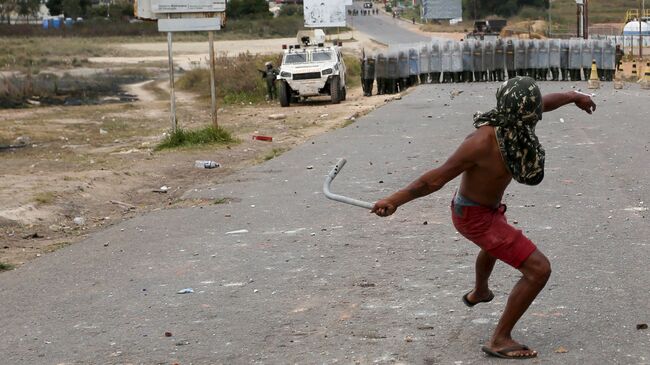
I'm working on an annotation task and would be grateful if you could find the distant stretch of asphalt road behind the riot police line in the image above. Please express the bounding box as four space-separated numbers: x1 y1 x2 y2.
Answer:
347 2 431 46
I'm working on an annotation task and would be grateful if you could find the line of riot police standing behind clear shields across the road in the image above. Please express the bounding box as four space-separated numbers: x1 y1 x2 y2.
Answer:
361 38 616 96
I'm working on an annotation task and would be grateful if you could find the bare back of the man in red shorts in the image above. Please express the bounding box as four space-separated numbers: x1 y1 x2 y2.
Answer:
459 126 512 206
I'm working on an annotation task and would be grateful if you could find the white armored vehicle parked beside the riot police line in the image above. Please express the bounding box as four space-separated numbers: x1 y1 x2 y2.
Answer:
278 29 346 107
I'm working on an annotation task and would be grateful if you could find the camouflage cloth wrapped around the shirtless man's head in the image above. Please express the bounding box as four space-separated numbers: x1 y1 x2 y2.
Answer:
474 76 545 185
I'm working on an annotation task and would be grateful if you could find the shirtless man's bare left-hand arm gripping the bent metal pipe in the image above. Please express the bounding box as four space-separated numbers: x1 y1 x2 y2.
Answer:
371 131 494 217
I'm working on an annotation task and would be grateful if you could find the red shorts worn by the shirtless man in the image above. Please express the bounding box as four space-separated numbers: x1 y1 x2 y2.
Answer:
451 198 537 268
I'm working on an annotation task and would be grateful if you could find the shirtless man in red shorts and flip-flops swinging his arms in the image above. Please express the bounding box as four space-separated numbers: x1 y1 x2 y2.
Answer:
372 77 596 358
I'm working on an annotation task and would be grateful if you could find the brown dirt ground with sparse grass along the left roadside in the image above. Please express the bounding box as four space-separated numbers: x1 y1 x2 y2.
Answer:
0 57 387 266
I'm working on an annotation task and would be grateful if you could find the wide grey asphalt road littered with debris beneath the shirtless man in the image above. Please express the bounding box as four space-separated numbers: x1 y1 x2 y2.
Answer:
0 82 650 365
